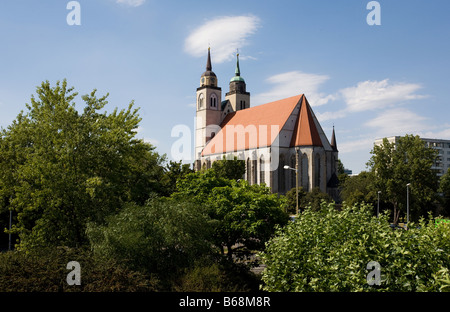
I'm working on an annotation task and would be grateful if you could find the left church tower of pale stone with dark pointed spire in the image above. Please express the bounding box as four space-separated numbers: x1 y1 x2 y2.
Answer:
195 48 222 166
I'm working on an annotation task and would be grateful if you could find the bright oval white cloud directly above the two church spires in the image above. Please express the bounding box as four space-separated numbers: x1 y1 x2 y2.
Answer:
184 15 260 63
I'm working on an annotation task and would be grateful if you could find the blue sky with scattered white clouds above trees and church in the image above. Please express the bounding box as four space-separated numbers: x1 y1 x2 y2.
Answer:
0 0 450 173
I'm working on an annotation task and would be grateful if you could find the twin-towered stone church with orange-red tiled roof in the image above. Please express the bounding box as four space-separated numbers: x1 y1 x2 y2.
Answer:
194 49 338 198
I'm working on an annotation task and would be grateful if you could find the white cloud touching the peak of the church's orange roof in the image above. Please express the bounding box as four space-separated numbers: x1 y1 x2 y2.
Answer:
252 71 335 106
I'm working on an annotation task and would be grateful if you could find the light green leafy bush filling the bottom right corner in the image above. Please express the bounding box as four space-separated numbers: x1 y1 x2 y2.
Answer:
261 203 450 291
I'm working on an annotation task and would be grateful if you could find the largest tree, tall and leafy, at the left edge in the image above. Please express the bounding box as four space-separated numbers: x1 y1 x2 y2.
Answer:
0 80 164 249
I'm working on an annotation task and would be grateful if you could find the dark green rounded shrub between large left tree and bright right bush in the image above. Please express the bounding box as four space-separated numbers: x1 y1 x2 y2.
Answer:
87 198 211 279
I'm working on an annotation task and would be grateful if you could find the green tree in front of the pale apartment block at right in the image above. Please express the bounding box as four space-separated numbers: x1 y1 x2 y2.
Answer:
368 135 437 223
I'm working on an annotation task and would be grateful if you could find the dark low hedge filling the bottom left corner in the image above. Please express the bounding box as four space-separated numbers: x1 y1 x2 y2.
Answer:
0 247 159 292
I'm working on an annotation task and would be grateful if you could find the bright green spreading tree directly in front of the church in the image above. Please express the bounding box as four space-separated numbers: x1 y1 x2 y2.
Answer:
172 168 288 258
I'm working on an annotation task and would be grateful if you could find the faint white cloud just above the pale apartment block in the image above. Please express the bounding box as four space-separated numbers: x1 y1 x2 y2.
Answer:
366 108 429 137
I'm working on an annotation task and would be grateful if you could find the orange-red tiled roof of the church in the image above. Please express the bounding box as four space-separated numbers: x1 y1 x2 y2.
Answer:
202 94 322 156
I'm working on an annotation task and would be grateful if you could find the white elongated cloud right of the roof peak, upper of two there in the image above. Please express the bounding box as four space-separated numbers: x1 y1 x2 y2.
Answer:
340 79 425 112
